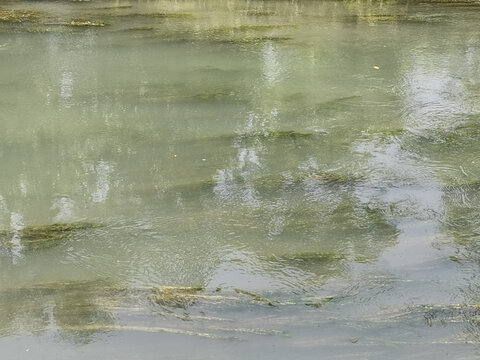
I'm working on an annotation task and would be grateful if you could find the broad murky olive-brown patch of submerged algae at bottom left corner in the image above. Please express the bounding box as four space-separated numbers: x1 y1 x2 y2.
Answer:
0 279 115 344
